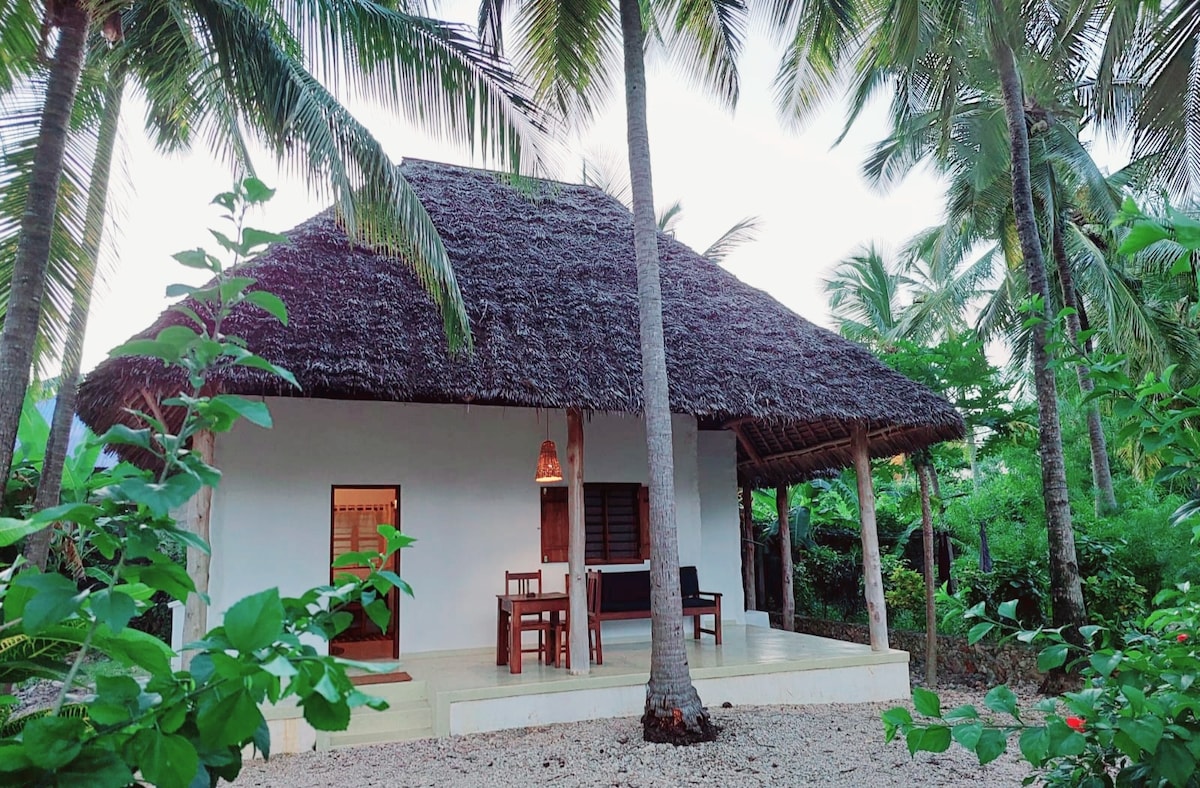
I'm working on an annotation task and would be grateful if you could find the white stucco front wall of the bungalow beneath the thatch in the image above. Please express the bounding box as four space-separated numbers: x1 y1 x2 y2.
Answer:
210 398 742 654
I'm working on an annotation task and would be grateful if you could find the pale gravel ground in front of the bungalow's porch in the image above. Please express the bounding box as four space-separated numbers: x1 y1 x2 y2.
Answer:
236 690 1032 788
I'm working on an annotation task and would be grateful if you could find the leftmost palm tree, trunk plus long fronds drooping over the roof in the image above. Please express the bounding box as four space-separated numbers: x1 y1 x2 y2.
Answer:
0 0 541 498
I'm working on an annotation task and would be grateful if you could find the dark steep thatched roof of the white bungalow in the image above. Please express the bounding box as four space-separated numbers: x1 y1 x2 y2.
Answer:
79 161 962 483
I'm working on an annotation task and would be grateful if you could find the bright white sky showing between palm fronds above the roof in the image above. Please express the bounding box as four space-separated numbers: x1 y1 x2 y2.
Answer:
84 9 942 369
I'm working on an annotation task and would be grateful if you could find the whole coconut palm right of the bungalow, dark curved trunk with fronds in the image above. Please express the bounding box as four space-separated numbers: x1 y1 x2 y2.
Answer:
773 0 1093 627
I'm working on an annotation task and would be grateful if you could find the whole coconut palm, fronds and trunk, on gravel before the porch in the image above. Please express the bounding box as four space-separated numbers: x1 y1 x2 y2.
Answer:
479 0 744 742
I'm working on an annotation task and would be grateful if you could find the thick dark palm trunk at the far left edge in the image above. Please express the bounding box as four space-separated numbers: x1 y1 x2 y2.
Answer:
0 7 88 491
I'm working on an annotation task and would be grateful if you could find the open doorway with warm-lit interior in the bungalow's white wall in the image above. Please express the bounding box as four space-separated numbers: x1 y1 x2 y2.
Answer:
329 486 400 660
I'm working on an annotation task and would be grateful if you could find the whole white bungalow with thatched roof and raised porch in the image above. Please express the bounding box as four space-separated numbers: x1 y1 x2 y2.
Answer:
79 161 962 750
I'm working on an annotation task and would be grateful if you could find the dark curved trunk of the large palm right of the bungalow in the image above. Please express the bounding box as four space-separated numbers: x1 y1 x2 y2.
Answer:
992 29 1086 636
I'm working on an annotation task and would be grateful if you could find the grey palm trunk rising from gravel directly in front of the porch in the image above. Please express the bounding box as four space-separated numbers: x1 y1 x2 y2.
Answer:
620 0 716 744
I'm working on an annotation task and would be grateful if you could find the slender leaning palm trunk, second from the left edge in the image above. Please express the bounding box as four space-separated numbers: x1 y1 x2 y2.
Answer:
25 66 125 570
